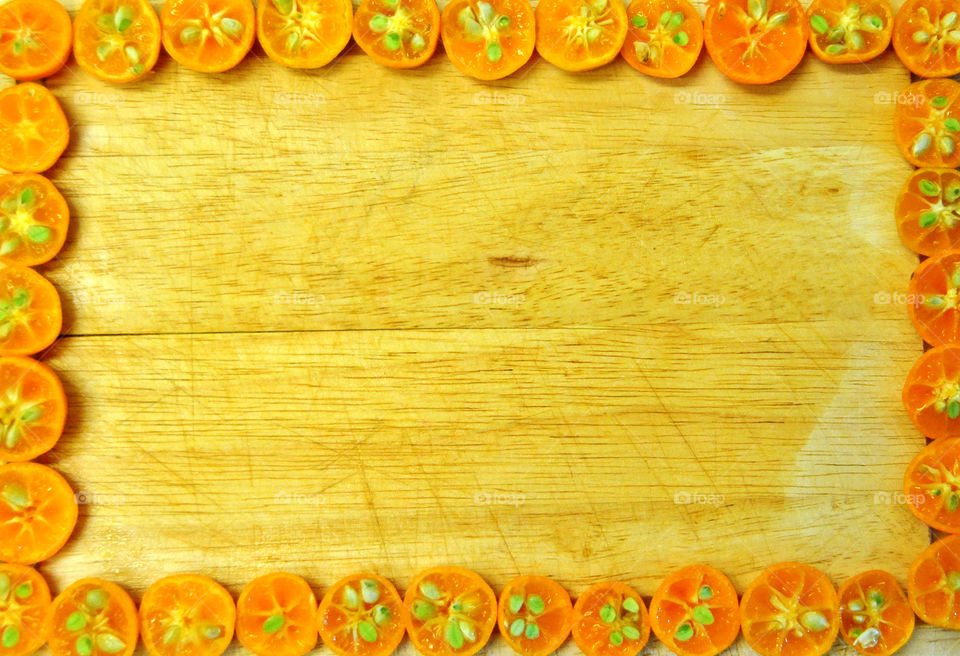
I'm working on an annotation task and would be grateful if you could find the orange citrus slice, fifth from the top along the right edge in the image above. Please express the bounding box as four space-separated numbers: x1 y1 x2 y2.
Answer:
903 346 960 439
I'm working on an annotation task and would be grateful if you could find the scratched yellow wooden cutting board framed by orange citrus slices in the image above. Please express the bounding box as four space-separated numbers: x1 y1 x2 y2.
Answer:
3 3 955 654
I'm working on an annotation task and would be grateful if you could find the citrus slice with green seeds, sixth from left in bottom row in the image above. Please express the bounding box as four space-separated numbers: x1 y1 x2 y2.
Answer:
403 567 497 656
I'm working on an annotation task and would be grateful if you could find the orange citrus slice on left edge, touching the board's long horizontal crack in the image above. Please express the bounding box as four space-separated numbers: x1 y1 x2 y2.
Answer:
0 265 63 355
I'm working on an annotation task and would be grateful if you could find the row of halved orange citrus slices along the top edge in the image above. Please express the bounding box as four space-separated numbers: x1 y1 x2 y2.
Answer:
0 0 960 84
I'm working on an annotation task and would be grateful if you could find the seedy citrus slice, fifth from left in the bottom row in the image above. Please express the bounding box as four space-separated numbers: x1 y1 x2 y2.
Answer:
317 574 405 656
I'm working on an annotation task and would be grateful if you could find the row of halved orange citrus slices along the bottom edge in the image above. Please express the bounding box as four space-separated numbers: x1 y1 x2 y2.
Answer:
0 560 960 656
